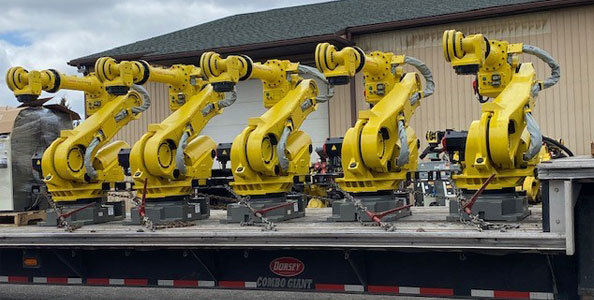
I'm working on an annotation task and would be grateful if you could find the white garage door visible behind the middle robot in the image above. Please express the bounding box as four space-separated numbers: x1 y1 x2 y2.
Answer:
202 80 329 168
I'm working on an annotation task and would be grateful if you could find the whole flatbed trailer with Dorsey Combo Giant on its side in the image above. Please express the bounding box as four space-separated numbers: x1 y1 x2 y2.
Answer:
0 157 594 299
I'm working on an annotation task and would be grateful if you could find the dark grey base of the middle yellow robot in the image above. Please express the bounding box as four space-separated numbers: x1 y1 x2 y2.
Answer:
221 194 305 224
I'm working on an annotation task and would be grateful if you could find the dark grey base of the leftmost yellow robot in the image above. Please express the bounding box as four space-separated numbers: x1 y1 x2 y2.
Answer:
39 200 126 226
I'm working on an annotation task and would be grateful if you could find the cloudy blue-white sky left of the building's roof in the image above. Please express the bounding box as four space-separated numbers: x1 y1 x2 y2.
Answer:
0 0 324 115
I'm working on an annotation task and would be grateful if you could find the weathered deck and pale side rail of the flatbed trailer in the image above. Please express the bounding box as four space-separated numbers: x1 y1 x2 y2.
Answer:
0 207 565 252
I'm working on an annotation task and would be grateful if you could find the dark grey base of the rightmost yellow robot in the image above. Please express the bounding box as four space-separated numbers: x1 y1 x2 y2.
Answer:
446 191 530 222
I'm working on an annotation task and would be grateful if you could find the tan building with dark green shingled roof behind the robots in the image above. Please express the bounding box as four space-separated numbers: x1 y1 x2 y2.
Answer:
70 0 594 154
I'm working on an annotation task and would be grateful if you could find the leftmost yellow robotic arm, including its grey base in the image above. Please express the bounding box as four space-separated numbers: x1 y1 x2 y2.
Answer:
6 67 150 225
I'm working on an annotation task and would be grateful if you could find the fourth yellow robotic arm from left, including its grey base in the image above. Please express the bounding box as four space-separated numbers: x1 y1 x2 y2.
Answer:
315 43 434 221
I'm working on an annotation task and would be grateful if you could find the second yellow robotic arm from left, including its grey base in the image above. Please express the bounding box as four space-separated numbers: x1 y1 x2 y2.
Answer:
92 58 236 224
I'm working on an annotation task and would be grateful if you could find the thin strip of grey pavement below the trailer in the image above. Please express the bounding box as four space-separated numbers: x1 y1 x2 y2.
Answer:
0 285 440 300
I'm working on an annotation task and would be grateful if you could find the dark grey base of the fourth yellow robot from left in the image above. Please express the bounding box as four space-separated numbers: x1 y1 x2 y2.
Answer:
327 191 412 222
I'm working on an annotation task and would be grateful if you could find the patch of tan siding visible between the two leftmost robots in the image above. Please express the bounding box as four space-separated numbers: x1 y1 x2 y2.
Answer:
114 82 170 147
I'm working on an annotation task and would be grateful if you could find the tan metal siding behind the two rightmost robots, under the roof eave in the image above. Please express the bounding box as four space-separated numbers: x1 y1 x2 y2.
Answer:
352 5 594 154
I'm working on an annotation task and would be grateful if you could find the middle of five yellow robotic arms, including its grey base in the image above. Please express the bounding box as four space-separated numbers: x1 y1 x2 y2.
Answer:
200 52 332 223
